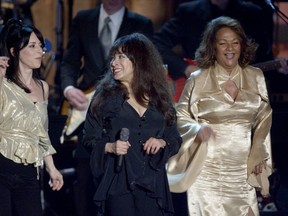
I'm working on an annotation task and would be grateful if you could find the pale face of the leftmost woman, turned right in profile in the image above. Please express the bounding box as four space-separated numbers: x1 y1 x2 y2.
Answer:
19 32 43 69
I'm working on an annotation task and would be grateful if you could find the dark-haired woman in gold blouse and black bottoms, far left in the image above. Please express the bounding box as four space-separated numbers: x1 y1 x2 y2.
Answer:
0 19 63 216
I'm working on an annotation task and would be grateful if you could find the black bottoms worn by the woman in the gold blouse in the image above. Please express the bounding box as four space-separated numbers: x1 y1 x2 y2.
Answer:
0 154 43 216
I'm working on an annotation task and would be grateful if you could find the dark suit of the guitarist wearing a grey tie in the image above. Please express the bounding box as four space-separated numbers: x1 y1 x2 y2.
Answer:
60 6 153 216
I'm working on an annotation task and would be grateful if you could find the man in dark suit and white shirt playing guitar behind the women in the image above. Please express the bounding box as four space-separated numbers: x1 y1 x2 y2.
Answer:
60 0 153 216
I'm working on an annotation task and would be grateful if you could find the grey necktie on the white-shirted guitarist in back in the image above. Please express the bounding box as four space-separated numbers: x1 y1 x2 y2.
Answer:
100 16 112 58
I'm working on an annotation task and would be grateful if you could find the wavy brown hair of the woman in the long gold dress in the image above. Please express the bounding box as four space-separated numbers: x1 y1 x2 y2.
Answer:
195 16 258 68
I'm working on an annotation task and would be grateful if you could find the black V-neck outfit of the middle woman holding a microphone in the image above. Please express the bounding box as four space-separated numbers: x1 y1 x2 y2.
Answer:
83 93 182 215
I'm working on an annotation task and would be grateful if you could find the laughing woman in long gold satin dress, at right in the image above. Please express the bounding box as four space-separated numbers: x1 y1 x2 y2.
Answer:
167 17 272 216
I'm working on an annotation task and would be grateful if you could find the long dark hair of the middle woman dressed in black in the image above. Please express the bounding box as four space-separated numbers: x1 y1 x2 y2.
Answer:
92 33 176 124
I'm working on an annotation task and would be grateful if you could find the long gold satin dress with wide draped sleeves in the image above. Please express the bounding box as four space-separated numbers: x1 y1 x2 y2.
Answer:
167 63 272 216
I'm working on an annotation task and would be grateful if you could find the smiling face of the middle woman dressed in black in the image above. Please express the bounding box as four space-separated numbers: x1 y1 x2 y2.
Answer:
110 52 134 86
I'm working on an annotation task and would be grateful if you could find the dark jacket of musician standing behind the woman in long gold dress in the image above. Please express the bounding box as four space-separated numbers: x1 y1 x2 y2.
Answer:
153 0 273 80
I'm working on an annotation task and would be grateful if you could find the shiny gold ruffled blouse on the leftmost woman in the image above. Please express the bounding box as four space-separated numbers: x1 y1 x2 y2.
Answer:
0 78 55 166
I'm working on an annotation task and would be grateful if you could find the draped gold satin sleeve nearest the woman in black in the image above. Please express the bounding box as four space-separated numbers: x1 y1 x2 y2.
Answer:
167 71 207 193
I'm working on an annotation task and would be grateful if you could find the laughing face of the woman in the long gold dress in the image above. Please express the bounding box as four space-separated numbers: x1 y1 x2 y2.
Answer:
215 27 241 73
